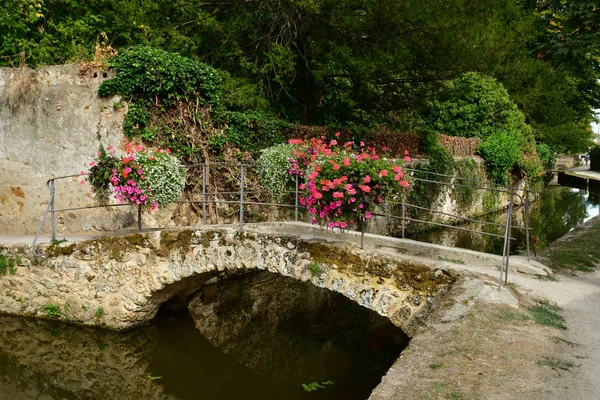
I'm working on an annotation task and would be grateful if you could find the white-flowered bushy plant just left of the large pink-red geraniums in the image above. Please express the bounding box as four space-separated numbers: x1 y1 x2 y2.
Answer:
257 143 294 202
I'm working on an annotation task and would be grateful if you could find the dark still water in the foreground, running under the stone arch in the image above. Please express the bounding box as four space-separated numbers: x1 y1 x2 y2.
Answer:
0 273 408 400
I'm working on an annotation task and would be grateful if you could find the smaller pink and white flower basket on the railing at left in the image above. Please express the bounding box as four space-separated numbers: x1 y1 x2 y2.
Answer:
82 144 186 210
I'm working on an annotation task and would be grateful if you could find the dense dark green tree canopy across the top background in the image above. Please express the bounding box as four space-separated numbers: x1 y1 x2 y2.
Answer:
0 0 600 152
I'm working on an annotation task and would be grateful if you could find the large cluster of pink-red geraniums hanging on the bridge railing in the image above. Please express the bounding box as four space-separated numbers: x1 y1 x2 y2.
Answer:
288 134 410 229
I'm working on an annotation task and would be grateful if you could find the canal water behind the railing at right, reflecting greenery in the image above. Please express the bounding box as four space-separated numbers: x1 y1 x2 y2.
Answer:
410 186 600 254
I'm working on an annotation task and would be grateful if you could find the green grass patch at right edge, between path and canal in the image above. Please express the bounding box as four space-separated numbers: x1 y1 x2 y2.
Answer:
542 222 600 272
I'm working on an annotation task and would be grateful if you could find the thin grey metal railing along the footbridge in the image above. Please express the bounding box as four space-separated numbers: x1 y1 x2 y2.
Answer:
33 163 535 288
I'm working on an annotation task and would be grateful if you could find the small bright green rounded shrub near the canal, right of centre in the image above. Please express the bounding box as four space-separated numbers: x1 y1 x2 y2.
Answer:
479 132 523 185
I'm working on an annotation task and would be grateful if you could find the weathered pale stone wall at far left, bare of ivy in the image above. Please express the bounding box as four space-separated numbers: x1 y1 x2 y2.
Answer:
0 65 132 235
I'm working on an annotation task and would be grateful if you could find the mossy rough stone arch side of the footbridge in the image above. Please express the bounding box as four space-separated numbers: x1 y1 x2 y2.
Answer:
0 228 453 333
